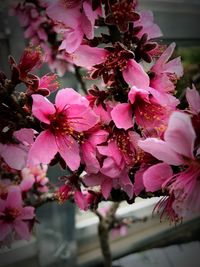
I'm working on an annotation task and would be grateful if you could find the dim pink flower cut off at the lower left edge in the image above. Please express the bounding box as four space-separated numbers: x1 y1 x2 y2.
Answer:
0 187 35 241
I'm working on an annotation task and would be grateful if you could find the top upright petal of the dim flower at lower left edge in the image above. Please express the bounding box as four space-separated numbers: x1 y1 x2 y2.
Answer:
6 187 22 209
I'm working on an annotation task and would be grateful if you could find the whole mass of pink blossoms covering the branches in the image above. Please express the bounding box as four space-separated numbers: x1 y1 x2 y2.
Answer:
0 0 200 245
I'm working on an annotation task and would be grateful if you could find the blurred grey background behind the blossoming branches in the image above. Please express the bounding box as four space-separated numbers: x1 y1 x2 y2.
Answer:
0 0 200 267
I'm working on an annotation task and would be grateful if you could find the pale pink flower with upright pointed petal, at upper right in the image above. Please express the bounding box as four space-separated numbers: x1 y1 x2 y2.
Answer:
150 43 183 92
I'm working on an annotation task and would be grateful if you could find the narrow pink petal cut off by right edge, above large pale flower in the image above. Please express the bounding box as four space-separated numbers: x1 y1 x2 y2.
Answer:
186 85 200 114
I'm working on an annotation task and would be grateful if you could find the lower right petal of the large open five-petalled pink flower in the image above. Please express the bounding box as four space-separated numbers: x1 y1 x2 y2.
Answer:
56 135 80 171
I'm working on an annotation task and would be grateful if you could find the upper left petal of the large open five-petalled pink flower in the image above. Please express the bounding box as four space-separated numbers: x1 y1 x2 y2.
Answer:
32 94 56 124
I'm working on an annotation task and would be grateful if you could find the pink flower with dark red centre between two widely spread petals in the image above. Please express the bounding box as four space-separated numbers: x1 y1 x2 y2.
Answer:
71 44 149 88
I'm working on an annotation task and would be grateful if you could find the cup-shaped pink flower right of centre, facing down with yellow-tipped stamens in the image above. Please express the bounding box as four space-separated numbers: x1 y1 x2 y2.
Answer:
111 86 176 135
